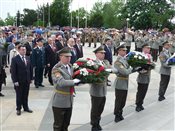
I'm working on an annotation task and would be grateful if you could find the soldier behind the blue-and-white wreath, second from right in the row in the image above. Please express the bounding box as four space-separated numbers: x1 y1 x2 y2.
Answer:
136 44 152 112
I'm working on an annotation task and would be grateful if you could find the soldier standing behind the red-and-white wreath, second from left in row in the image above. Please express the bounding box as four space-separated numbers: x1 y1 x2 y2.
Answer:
90 46 110 131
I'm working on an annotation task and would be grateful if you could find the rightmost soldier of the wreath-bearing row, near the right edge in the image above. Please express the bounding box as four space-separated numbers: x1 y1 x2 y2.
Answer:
158 41 171 101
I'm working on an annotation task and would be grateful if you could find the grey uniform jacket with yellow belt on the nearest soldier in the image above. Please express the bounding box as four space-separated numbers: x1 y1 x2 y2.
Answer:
52 62 74 108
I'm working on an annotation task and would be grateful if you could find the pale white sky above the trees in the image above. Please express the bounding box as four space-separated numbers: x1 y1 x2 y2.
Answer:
0 0 109 19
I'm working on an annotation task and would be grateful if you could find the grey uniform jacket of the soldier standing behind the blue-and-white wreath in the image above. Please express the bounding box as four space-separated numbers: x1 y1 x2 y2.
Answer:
137 53 152 84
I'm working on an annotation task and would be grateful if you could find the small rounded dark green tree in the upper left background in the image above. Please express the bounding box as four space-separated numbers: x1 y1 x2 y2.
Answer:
21 9 37 26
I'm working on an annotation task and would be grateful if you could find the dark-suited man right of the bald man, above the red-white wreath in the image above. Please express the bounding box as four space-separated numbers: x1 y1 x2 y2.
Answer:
74 38 83 59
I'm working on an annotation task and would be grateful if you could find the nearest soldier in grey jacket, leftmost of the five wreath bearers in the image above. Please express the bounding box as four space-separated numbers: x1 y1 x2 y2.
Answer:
52 47 80 131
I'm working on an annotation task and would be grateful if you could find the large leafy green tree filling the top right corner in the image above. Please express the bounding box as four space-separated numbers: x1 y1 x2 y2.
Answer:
122 0 174 29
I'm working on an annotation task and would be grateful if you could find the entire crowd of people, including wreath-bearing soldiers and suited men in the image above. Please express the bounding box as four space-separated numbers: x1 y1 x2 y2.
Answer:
0 27 175 131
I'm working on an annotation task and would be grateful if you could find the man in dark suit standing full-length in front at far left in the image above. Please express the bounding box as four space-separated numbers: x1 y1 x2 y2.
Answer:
11 45 33 115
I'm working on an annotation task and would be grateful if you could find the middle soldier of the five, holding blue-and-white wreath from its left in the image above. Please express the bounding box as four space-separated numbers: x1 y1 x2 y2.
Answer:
114 44 132 122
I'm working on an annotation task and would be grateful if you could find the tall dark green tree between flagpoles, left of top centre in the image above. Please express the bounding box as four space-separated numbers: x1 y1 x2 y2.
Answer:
50 0 70 26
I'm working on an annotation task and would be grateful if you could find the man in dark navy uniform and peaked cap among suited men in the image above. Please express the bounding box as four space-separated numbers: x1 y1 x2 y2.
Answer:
32 38 45 88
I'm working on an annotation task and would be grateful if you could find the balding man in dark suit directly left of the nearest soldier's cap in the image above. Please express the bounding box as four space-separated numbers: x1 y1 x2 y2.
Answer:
45 38 56 85
